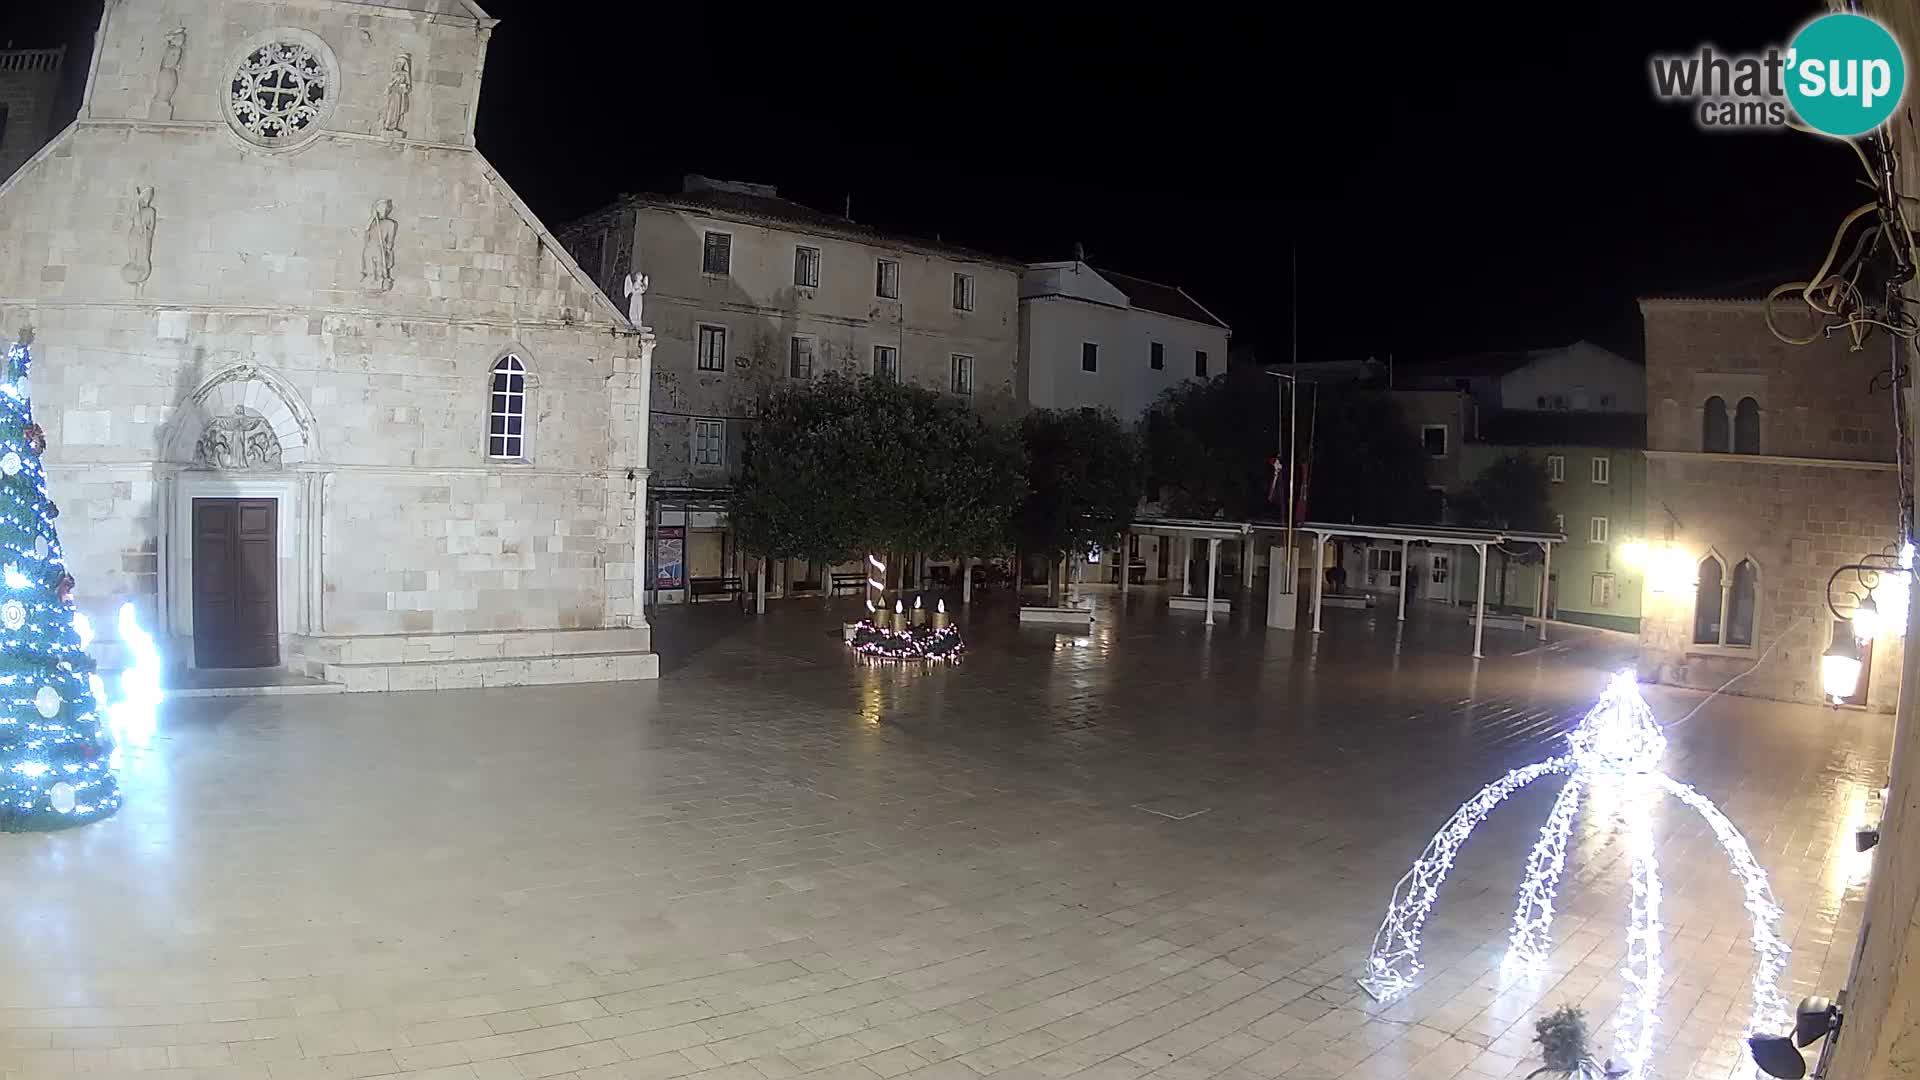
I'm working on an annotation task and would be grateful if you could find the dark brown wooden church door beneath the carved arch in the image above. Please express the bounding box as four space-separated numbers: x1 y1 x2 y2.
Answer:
194 500 280 667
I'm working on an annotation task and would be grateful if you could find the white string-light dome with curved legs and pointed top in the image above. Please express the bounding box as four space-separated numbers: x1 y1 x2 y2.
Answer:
1359 671 1789 1080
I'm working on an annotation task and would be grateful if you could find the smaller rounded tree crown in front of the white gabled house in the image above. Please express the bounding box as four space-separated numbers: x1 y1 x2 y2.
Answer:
1018 409 1140 563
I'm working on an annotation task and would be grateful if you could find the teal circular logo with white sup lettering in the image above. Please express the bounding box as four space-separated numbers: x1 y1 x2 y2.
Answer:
1788 15 1907 136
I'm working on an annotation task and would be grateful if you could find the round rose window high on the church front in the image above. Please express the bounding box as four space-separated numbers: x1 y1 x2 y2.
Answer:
221 27 340 150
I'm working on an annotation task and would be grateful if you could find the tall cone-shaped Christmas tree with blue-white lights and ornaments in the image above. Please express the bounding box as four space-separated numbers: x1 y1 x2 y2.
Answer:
0 334 121 830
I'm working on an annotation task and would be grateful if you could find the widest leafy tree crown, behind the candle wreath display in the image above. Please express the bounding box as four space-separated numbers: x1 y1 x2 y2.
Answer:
730 373 1023 580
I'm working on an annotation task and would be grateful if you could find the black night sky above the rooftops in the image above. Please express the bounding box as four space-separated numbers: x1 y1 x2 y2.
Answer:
11 0 1860 361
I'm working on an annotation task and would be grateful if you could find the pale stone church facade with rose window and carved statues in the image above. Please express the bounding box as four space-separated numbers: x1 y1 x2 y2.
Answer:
0 0 657 690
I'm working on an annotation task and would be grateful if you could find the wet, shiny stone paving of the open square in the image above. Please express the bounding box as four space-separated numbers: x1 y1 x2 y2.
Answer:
0 592 1891 1080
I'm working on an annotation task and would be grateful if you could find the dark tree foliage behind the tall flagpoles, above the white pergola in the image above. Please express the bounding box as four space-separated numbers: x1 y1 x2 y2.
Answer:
1146 369 1438 525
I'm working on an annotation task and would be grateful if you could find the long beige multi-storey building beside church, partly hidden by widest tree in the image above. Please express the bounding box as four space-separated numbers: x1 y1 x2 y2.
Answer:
561 177 1021 603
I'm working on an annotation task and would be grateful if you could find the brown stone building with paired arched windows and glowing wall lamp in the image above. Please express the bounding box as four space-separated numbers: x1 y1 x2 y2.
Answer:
1640 298 1903 709
